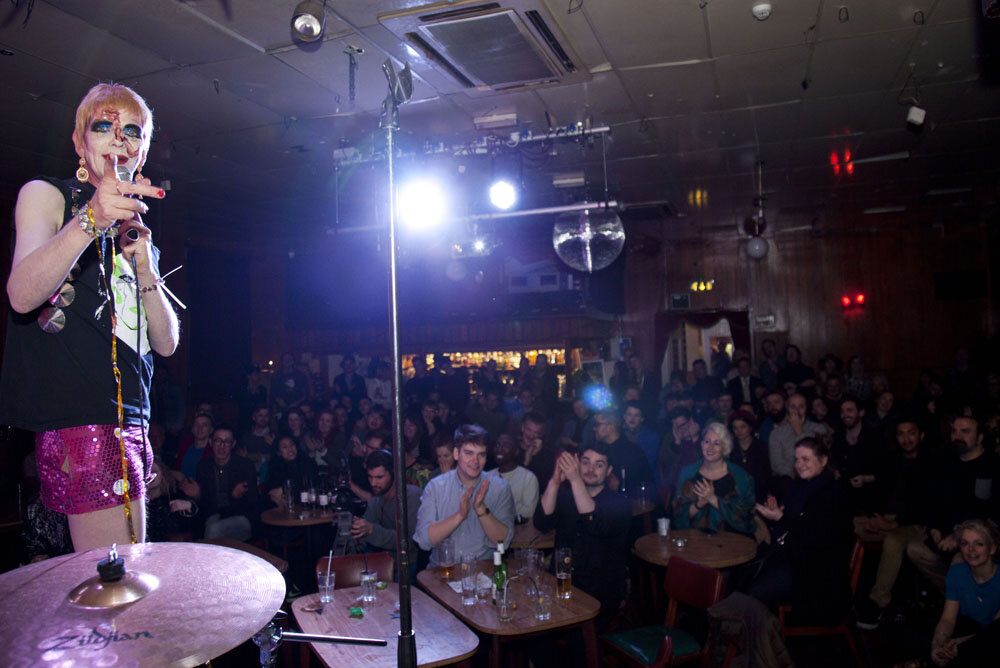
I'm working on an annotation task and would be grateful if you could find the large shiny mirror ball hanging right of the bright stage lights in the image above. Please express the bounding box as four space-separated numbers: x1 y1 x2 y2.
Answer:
552 209 625 274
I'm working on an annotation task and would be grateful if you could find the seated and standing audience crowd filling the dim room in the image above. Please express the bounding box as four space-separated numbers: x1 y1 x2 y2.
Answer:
15 340 1000 666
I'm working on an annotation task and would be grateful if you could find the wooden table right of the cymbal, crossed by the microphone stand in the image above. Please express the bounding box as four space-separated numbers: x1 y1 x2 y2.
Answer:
292 582 479 668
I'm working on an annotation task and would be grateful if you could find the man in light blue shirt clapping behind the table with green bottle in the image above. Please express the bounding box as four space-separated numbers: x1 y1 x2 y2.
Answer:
413 425 514 567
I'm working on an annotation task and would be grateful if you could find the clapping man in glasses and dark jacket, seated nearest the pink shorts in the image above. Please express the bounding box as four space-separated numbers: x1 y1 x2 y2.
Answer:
180 426 260 540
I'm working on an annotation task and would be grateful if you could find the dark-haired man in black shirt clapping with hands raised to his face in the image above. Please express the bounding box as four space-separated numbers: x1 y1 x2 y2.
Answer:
534 443 632 633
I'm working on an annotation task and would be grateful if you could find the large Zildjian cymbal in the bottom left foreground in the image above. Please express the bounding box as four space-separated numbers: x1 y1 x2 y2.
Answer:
0 543 285 668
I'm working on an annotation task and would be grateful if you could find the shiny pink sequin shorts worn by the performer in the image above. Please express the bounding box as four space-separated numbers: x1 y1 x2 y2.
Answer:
35 424 153 515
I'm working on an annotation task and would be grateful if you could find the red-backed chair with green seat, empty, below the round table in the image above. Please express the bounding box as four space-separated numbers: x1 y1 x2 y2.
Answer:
601 557 722 668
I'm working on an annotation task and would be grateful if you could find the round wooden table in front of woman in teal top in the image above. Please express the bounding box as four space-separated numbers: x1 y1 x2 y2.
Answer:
635 529 757 568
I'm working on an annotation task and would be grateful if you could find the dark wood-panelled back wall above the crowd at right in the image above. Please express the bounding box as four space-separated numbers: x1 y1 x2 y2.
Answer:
625 223 995 394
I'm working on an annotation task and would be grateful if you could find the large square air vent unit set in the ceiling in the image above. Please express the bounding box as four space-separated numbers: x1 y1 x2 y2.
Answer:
379 0 590 90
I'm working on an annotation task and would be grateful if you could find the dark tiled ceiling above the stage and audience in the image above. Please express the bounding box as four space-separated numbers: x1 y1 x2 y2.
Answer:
0 0 1000 245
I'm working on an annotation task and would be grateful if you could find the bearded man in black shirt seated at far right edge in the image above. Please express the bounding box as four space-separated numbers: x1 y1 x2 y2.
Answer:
906 416 1000 593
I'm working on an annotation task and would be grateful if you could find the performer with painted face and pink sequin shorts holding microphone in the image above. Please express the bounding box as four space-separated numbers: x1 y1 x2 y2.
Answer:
0 84 179 551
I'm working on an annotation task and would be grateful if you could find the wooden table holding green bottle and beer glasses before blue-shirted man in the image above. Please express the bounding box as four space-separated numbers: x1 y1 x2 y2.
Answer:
417 561 601 668
